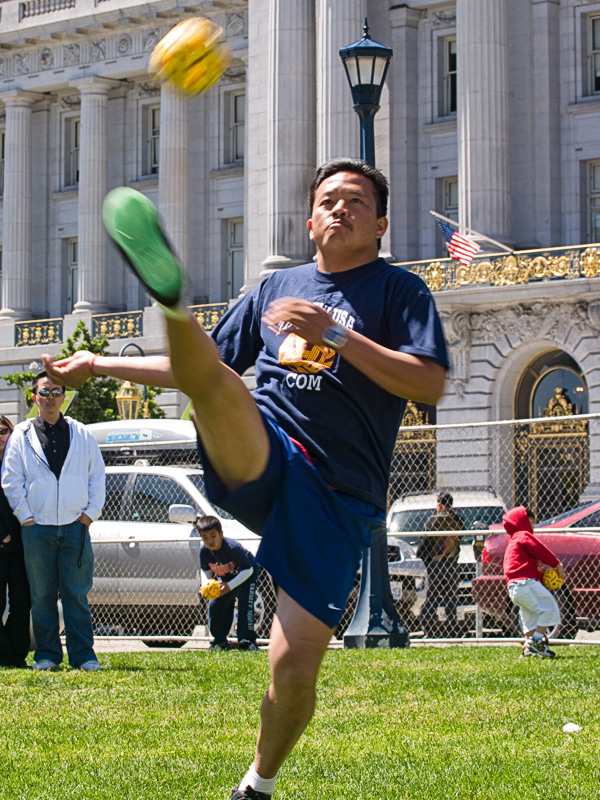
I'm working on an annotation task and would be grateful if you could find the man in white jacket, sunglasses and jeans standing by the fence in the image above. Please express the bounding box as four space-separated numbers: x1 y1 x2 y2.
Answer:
2 372 105 671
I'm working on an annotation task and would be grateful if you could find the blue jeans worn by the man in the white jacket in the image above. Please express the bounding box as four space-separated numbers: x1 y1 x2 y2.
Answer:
21 522 96 668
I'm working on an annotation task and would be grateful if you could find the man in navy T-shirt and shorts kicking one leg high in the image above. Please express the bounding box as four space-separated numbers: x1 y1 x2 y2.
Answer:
44 158 448 800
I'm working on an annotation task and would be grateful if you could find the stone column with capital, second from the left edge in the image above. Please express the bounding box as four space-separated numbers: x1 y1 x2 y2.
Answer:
70 77 119 314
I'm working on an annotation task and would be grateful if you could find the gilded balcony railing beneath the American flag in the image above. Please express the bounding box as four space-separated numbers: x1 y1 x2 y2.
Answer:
397 244 600 292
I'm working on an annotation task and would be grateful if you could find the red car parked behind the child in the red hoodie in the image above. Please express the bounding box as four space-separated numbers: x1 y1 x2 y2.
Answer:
473 500 600 639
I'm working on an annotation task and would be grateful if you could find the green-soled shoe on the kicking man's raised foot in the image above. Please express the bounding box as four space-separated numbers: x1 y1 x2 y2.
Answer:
102 186 185 306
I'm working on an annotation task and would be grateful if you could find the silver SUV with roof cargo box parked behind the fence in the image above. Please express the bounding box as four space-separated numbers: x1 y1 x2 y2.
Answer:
89 420 276 638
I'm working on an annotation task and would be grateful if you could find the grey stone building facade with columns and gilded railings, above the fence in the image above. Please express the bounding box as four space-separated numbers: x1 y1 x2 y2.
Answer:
0 0 600 512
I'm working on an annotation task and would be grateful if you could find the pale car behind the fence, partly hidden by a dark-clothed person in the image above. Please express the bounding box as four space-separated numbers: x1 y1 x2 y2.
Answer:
387 490 506 622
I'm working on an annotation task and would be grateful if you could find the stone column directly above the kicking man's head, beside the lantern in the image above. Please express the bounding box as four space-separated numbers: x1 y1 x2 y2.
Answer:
316 0 367 165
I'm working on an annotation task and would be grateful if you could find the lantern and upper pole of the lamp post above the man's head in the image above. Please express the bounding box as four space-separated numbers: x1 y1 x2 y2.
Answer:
340 19 393 167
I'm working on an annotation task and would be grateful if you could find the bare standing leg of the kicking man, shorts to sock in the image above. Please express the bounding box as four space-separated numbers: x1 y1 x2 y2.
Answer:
254 590 333 778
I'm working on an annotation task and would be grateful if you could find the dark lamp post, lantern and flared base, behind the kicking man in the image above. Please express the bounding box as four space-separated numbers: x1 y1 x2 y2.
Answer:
340 19 410 648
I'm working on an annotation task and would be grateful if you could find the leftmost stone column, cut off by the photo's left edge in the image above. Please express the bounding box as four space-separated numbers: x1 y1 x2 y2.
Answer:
0 90 46 320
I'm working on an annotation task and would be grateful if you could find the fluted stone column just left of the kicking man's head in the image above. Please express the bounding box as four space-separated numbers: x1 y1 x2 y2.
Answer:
262 0 316 272
